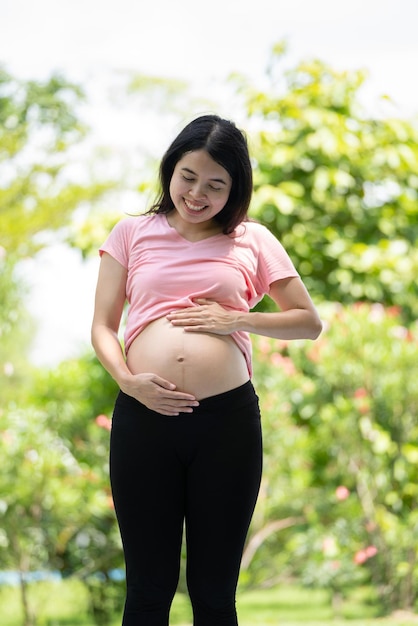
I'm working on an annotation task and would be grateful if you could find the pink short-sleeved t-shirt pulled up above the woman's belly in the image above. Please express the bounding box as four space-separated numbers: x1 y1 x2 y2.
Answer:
100 214 298 376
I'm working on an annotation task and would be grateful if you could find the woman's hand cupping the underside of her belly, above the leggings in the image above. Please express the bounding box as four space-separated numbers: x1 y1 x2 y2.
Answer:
119 373 199 416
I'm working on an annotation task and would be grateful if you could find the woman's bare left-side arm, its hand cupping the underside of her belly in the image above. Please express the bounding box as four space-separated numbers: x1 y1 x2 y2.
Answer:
91 253 198 415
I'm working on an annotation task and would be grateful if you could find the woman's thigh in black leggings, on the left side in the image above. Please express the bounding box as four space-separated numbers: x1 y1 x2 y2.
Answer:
110 394 185 587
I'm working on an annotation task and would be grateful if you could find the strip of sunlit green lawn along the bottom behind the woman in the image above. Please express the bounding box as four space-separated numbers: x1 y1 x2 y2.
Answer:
0 580 418 626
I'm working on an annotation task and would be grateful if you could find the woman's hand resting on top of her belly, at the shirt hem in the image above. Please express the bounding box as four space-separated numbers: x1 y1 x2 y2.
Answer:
166 298 236 335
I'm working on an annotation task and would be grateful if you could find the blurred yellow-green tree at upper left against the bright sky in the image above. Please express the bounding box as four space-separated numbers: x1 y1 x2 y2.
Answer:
0 68 114 390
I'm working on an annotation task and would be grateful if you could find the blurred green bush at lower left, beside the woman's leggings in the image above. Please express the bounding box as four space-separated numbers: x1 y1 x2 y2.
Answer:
0 402 100 626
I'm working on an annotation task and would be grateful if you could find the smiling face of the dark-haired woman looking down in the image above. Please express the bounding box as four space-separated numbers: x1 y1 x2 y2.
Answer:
170 150 232 224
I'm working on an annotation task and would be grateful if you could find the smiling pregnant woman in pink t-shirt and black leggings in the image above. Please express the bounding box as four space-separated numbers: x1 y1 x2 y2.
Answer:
92 115 321 626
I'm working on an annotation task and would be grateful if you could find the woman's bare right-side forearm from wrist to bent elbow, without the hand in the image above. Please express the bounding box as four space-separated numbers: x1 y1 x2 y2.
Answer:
236 309 322 340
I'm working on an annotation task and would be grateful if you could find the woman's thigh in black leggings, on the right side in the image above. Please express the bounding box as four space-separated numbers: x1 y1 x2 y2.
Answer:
186 388 262 597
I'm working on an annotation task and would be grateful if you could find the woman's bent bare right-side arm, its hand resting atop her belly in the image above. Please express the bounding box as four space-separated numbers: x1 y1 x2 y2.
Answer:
167 277 322 339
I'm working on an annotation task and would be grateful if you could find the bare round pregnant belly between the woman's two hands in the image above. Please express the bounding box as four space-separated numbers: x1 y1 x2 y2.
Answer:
127 318 249 400
